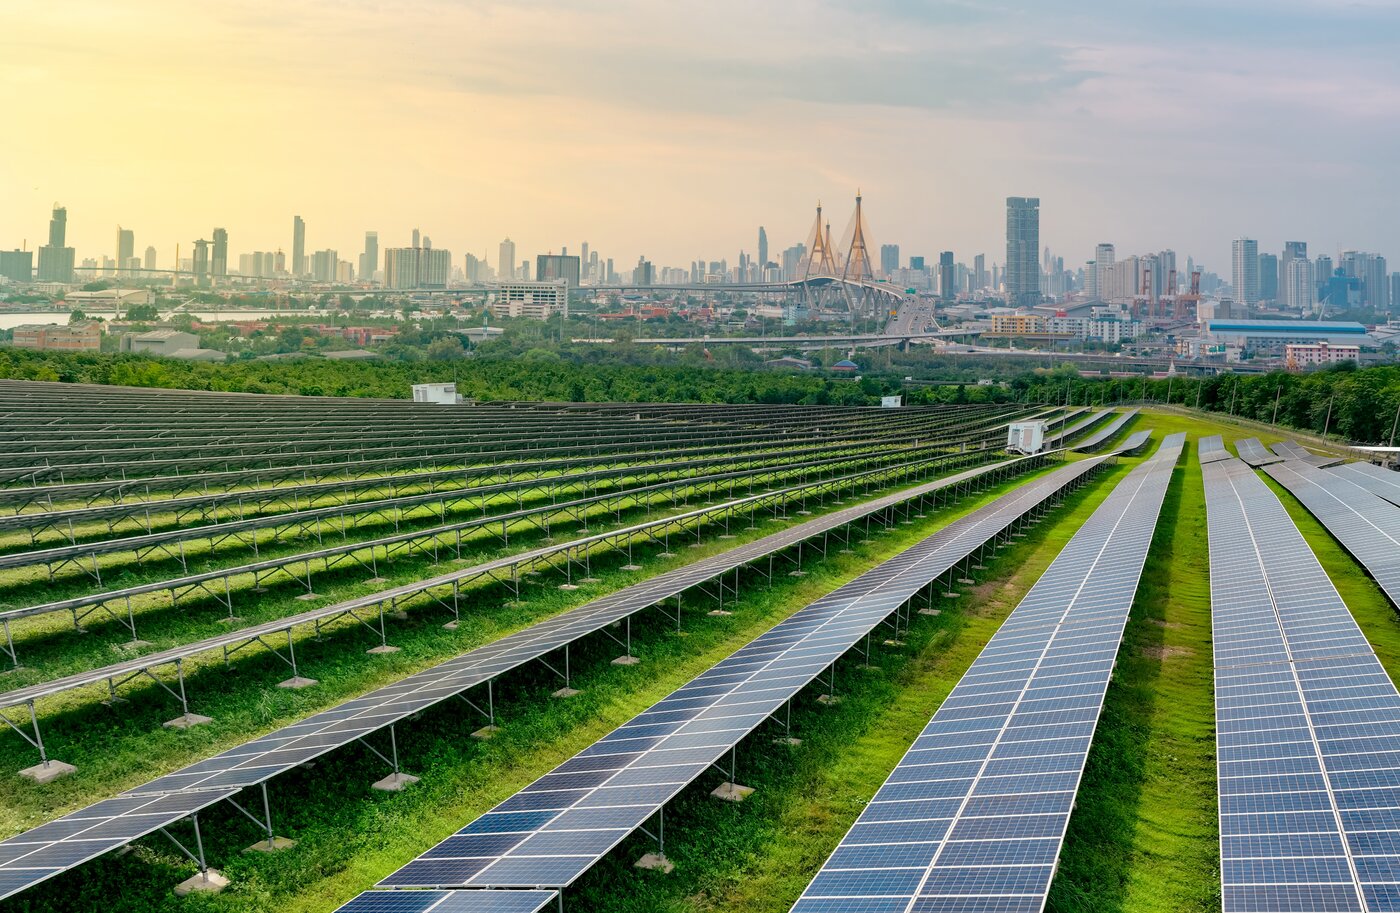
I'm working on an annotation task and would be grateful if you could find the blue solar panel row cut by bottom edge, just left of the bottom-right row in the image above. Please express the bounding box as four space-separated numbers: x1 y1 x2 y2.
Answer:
792 434 1186 913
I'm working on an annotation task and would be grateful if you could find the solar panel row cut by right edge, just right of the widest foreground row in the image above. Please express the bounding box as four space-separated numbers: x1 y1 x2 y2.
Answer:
1264 459 1400 606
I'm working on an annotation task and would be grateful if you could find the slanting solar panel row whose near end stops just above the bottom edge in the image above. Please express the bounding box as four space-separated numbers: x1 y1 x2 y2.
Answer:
366 458 1102 888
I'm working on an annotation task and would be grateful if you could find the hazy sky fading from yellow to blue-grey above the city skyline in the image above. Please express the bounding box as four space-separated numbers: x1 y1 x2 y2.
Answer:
0 0 1400 274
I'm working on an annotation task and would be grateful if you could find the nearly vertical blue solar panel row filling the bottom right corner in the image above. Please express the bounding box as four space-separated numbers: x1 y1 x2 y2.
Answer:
1204 461 1400 913
